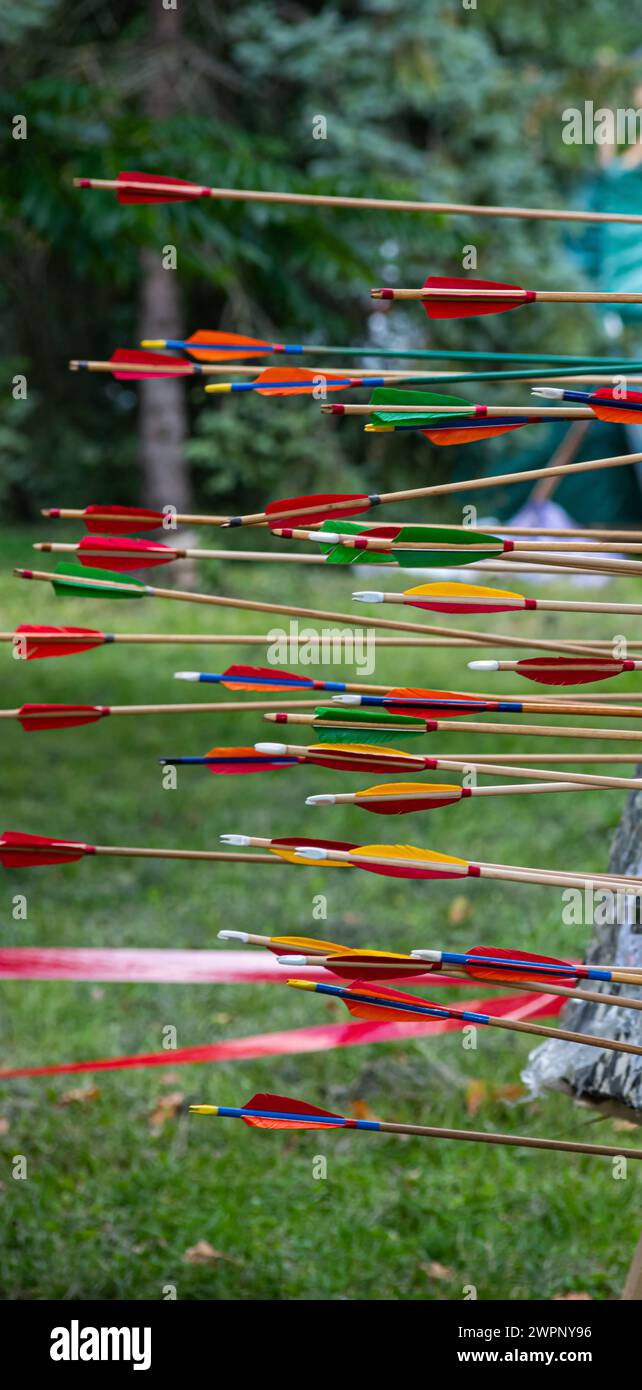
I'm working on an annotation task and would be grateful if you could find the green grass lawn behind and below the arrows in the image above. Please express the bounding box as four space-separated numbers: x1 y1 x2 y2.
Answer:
0 527 642 1300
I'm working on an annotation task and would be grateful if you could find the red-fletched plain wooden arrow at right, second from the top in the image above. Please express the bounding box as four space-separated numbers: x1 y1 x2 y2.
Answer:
370 275 642 318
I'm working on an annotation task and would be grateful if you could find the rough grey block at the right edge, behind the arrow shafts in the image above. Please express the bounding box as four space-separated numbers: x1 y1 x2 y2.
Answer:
524 767 642 1118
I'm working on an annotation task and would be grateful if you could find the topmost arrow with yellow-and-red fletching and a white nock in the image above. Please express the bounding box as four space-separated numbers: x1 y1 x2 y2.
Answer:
352 582 642 617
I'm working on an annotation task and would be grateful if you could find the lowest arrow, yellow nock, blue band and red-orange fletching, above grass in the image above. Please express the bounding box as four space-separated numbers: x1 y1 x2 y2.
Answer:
189 1091 642 1158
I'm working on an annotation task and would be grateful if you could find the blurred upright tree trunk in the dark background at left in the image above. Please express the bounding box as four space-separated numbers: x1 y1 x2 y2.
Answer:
139 0 192 512
